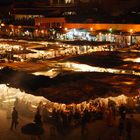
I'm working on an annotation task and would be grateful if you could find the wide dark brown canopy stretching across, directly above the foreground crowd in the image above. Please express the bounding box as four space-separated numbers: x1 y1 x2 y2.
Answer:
0 66 140 104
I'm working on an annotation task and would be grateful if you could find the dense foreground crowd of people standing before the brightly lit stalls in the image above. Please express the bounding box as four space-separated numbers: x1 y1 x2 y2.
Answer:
11 95 139 140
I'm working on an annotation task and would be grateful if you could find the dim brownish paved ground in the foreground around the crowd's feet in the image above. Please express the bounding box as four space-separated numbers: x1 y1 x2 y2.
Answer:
0 110 140 140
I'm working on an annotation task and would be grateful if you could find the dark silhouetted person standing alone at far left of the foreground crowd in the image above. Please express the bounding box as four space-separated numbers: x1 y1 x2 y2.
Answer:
11 107 18 130
